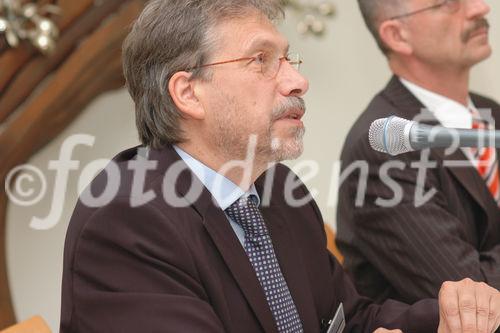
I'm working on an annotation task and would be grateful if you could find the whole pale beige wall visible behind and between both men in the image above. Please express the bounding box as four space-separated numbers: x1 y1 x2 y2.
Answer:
7 0 500 332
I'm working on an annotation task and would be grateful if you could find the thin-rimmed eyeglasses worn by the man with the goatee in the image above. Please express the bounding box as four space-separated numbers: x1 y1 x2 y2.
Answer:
188 52 303 79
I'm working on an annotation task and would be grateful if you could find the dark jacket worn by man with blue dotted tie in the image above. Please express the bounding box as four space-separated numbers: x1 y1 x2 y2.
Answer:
61 147 438 333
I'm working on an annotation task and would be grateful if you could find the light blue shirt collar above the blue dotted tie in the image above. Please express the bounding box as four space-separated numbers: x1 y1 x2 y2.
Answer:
174 145 260 210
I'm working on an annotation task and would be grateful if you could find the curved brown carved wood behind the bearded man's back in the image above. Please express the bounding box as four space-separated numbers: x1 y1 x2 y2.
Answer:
0 0 145 328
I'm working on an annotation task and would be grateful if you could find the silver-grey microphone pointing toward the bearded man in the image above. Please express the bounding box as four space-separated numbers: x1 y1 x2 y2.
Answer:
368 116 500 155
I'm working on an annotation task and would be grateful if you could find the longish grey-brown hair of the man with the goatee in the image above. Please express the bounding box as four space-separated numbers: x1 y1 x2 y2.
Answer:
123 0 284 148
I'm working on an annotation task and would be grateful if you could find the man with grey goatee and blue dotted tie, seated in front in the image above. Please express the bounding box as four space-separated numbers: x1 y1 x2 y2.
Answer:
61 0 500 333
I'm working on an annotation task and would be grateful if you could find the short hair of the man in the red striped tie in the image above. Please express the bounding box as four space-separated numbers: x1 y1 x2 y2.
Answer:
358 0 408 55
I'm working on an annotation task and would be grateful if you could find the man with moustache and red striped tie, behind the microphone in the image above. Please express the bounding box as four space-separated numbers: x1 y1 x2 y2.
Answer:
337 0 500 303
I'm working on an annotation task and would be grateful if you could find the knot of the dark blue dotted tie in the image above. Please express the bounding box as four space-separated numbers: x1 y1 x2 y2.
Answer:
226 195 267 237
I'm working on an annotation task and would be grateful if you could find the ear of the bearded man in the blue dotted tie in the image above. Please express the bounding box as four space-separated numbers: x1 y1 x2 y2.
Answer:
168 71 205 120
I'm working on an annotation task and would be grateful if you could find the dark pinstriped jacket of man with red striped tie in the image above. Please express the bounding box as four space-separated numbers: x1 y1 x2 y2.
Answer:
337 77 500 303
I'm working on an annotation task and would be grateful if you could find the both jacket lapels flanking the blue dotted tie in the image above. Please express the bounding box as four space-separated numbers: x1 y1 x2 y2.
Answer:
195 165 319 333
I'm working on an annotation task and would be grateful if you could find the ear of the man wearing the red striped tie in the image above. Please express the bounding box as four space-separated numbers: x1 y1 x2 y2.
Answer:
378 20 413 55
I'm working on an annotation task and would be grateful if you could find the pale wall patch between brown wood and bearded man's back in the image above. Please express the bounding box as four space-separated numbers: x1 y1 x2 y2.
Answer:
6 89 138 332
